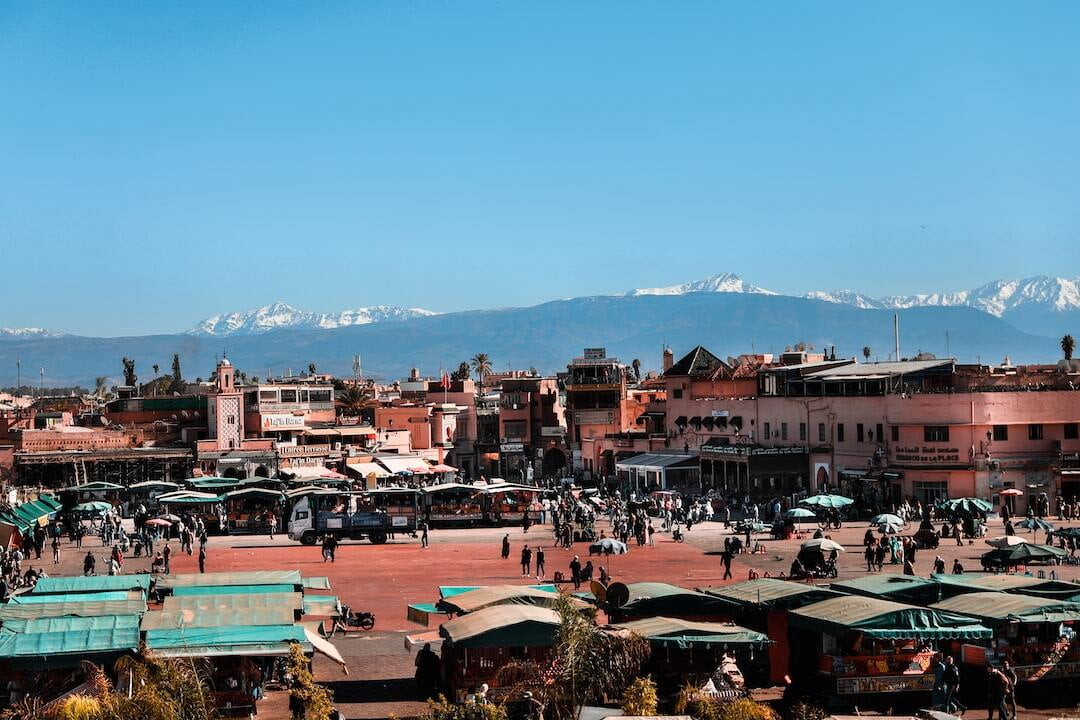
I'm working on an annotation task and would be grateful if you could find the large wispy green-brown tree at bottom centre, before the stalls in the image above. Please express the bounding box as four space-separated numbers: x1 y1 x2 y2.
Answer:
499 594 649 720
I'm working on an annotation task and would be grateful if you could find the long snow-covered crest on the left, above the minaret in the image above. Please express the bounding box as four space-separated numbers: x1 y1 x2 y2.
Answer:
188 302 437 338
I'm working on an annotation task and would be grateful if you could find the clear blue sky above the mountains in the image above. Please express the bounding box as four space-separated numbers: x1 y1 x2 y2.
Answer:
0 0 1080 335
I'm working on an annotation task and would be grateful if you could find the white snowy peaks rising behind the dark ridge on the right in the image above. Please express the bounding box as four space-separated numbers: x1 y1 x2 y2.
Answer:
626 273 1080 317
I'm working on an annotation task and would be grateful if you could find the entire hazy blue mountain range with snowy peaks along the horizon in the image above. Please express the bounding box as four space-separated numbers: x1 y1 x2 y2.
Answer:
0 274 1080 385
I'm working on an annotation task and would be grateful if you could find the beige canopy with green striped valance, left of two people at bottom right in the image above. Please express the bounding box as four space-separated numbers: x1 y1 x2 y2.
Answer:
791 595 994 640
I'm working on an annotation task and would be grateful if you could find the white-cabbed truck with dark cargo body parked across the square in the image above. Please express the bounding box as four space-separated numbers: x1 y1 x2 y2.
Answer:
287 489 418 545
